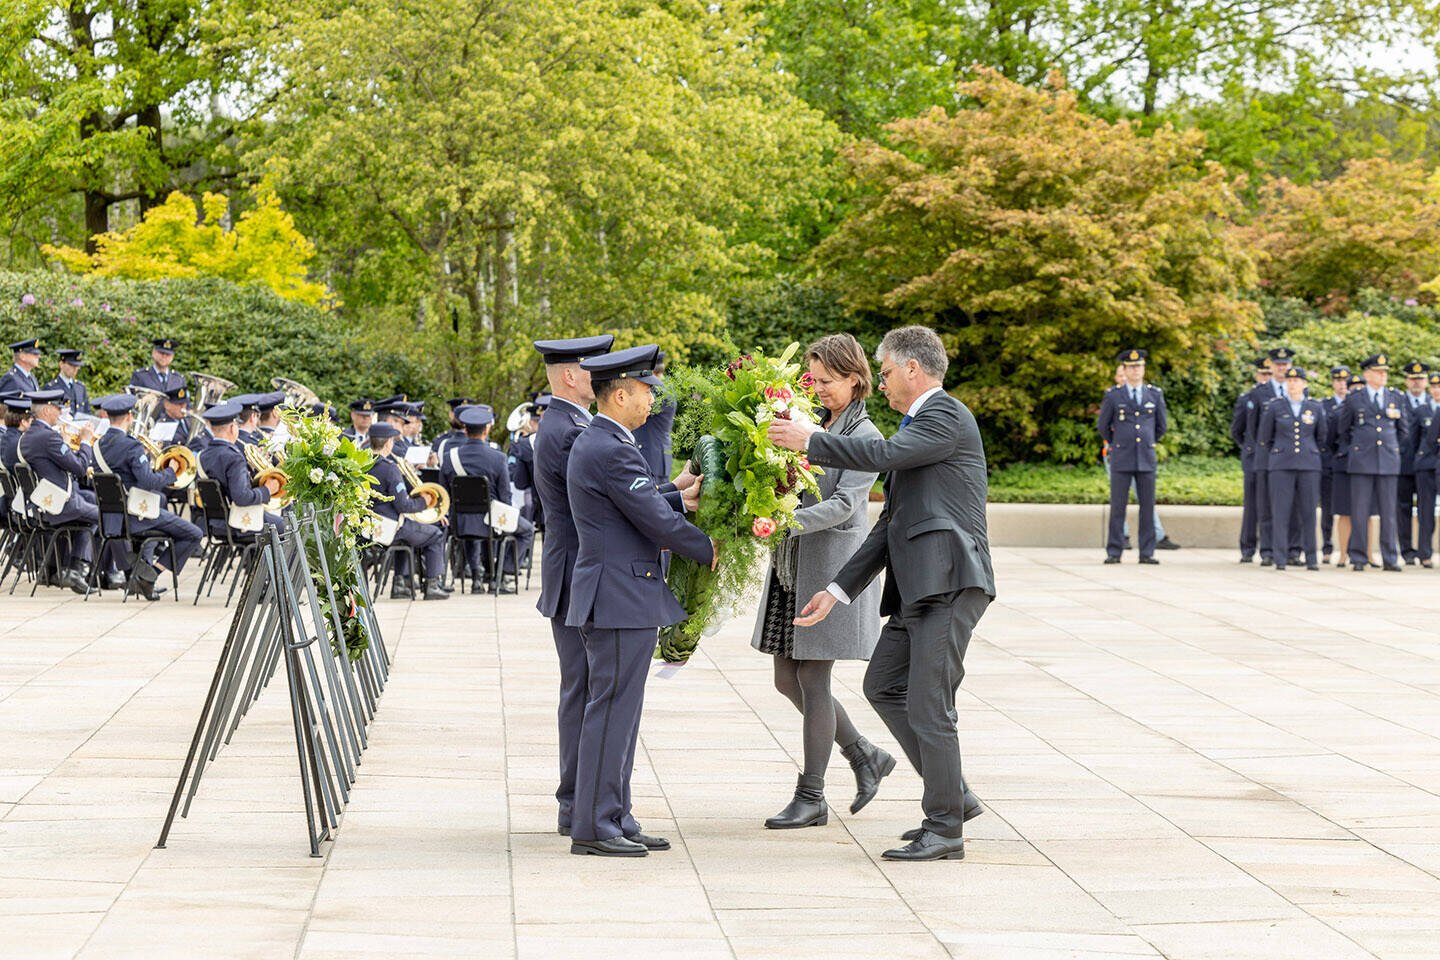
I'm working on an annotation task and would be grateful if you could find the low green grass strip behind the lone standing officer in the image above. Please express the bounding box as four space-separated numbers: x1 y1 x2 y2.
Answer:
989 456 1244 505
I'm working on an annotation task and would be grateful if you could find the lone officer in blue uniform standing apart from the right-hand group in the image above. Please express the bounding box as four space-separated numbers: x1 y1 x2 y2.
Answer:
1096 350 1169 564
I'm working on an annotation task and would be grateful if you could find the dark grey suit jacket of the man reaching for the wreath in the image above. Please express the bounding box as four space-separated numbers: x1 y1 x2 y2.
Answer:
809 391 995 616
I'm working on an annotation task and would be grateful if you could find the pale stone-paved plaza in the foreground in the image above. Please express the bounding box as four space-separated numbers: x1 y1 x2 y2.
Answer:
0 548 1440 960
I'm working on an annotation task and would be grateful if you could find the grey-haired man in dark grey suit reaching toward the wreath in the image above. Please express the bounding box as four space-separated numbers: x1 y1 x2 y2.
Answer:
769 327 995 861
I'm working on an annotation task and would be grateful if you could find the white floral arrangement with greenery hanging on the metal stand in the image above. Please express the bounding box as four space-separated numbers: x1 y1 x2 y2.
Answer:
282 410 374 661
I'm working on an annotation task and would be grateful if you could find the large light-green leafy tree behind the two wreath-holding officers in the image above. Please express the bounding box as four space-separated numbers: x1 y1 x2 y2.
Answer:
255 0 835 402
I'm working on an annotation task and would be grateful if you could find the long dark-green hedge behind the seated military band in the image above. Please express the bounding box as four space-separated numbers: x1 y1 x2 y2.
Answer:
0 272 444 410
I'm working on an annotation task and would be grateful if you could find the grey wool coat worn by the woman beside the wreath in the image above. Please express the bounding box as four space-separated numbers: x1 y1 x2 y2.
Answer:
750 400 884 661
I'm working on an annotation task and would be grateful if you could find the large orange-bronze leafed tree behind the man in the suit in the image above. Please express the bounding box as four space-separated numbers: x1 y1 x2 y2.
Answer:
815 72 1259 461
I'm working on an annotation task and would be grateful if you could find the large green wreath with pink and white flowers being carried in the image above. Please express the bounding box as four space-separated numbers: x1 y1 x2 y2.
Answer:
657 343 819 664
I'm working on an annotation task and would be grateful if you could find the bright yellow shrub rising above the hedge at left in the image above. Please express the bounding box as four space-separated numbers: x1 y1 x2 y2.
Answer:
43 180 327 307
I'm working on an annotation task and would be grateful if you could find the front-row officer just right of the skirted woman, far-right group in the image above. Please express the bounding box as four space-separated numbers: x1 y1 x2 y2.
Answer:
1336 353 1410 573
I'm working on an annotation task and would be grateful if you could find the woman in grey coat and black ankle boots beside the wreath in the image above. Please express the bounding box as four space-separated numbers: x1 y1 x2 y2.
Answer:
752 334 896 829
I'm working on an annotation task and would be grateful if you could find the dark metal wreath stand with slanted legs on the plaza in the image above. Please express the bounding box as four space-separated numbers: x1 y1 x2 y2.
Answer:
156 508 390 856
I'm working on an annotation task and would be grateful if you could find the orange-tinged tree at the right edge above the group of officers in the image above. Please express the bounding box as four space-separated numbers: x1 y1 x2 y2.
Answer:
1241 157 1440 312
